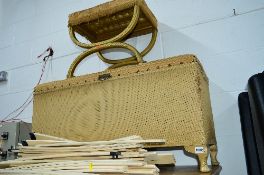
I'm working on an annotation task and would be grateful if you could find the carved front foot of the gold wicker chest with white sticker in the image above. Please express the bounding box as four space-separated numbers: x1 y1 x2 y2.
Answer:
184 145 211 172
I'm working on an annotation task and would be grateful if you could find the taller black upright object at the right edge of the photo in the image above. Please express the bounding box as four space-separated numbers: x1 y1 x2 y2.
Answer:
248 73 264 174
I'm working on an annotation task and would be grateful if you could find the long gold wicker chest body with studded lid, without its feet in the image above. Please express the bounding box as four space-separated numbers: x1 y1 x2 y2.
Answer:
33 55 215 146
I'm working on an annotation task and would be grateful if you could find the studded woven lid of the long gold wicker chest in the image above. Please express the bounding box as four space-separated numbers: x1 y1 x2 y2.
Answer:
34 54 208 95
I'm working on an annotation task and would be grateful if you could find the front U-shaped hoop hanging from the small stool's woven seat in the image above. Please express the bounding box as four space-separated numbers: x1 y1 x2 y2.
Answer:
69 5 140 49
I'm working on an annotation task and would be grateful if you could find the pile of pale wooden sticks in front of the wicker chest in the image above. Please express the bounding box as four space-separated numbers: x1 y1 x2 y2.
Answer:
0 133 175 175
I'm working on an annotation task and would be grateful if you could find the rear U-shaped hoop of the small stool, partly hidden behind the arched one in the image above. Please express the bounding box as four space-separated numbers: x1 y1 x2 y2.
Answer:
97 29 158 64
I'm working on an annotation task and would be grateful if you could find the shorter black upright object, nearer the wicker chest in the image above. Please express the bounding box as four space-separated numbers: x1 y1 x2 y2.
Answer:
238 92 261 175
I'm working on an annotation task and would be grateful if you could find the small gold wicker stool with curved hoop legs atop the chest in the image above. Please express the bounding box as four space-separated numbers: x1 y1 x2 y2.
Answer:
68 0 157 77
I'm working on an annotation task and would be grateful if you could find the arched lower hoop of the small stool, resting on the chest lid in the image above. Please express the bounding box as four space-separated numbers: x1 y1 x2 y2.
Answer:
67 42 143 78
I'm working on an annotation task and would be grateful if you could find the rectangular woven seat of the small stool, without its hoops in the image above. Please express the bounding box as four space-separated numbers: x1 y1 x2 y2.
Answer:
68 0 157 42
